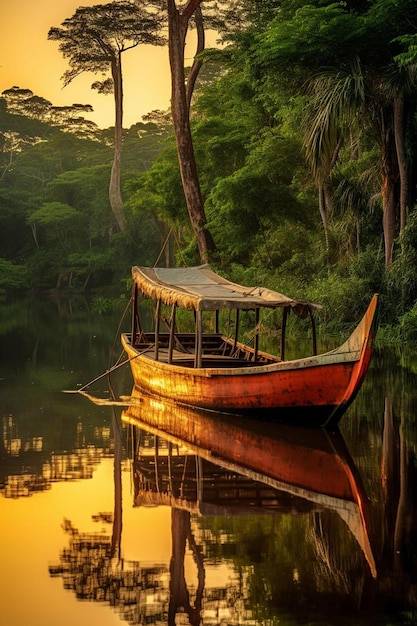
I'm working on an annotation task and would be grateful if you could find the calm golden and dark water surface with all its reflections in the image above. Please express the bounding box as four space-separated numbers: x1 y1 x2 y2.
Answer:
0 298 417 626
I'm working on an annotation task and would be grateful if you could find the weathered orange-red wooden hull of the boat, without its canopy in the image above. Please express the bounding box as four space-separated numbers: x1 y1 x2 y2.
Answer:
122 298 376 427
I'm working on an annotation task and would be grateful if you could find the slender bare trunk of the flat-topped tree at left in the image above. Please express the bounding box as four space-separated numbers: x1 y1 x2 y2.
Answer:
109 52 125 231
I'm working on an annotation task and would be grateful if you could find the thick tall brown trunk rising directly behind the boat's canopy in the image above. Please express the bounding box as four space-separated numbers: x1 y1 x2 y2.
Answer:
168 0 215 263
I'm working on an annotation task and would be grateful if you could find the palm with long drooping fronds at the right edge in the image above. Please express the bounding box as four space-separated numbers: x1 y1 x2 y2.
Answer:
304 57 417 267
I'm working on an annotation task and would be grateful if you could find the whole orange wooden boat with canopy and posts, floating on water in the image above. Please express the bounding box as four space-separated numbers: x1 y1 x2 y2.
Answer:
121 265 378 427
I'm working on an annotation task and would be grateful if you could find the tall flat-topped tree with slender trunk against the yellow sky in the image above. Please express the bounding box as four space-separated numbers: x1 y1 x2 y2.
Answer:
48 1 164 231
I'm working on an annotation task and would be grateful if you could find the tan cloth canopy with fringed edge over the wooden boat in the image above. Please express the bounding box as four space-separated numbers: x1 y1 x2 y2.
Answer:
132 265 321 317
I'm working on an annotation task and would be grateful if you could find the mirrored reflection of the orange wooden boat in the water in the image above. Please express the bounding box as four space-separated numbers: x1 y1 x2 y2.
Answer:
122 389 376 576
